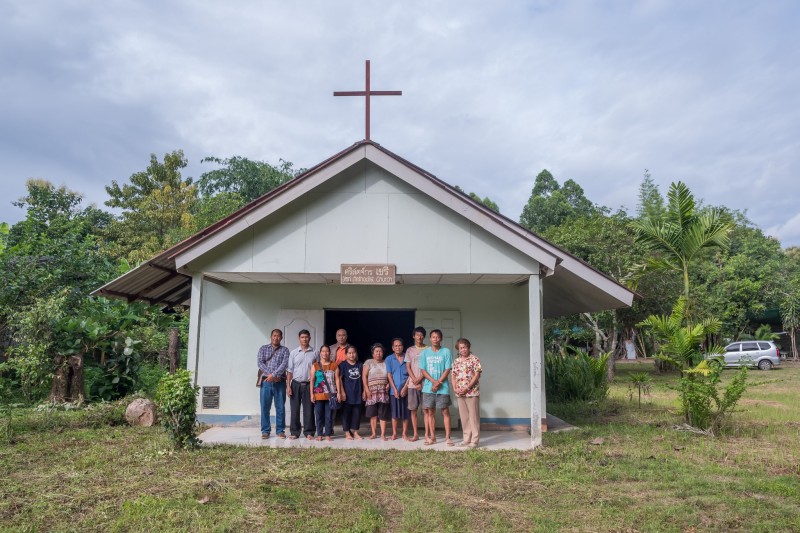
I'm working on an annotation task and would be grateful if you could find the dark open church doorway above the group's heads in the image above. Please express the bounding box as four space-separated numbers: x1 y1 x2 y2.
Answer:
325 309 414 361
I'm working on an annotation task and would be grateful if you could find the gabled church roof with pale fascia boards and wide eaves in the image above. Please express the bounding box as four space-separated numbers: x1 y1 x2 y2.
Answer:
94 141 633 316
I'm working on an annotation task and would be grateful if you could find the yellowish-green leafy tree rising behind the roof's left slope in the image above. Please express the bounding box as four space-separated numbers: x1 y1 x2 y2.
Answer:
106 150 197 263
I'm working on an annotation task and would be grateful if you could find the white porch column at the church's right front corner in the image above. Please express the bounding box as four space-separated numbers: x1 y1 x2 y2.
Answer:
528 274 546 448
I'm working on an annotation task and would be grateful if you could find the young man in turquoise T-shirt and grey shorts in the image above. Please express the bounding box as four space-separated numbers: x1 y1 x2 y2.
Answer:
419 329 454 446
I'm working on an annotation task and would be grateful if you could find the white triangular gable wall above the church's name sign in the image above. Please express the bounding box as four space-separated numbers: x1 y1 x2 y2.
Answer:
189 162 538 274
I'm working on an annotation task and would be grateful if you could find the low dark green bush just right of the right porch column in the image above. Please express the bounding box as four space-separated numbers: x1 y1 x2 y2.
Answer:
544 350 609 402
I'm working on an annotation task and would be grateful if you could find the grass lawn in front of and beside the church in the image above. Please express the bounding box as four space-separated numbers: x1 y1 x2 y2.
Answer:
0 363 800 532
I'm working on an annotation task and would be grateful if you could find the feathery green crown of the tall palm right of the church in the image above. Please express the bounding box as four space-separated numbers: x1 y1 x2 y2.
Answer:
631 181 734 300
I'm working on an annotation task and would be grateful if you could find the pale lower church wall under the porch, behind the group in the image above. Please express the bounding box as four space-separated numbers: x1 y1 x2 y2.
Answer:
196 283 531 424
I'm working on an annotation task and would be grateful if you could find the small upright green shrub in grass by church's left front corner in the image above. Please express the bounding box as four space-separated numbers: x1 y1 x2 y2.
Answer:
156 369 200 449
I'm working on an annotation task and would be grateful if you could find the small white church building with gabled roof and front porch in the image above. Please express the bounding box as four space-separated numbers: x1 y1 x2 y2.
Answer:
97 139 633 446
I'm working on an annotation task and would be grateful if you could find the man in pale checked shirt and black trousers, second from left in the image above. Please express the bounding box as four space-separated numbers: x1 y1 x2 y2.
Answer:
286 329 317 440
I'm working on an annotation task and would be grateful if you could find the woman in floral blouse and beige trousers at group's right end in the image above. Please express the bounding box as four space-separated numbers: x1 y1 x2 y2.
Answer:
450 339 482 448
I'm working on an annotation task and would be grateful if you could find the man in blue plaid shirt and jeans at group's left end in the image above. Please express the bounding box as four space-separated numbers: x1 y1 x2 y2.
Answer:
258 329 289 439
